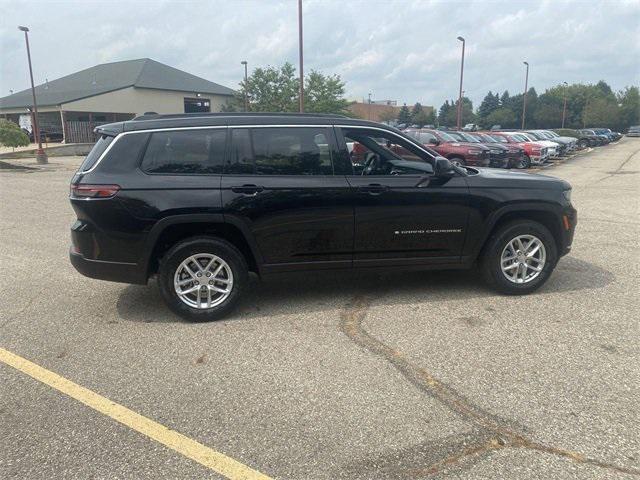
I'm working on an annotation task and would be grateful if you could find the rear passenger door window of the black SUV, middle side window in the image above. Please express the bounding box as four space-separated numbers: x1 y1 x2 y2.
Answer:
227 127 333 175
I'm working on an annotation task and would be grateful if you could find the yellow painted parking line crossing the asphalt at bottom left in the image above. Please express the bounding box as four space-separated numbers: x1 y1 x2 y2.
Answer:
0 347 269 480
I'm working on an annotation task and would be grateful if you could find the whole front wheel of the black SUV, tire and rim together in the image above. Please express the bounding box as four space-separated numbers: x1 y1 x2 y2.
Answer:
480 220 558 295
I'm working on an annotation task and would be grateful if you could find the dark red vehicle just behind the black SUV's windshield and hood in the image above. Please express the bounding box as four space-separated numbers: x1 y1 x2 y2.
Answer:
405 129 491 167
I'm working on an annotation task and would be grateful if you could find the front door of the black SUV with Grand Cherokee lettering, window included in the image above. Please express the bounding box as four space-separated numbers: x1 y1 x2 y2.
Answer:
338 127 469 266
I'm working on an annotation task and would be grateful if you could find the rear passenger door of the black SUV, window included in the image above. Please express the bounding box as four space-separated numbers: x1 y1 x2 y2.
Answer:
221 126 353 273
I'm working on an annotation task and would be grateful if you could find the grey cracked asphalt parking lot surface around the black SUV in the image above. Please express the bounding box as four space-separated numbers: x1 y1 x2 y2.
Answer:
0 138 640 479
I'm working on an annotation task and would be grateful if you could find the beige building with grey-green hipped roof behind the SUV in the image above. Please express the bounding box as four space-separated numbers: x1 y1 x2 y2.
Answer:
0 58 235 143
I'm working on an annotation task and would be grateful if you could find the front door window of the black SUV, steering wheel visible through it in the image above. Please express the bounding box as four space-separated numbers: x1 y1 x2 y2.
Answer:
343 128 433 175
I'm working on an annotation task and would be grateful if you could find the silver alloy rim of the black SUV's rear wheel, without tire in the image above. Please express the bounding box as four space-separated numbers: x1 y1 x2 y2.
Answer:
173 253 233 309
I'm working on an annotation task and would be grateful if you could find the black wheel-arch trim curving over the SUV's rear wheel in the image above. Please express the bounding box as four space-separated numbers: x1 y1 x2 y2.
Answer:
140 213 263 272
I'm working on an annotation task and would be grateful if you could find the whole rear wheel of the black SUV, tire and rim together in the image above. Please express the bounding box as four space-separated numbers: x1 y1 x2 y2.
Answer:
158 237 249 322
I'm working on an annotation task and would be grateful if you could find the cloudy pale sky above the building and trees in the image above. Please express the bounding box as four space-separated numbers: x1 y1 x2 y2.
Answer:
0 0 640 106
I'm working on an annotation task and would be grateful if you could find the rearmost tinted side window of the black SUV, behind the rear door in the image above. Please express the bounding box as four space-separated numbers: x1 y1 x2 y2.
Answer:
142 129 227 174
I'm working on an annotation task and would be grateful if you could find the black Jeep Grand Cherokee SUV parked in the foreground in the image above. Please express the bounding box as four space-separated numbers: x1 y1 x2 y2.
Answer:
70 114 577 320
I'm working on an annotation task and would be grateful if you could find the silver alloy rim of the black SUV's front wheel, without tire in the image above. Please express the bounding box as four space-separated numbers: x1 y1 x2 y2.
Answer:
500 235 547 284
